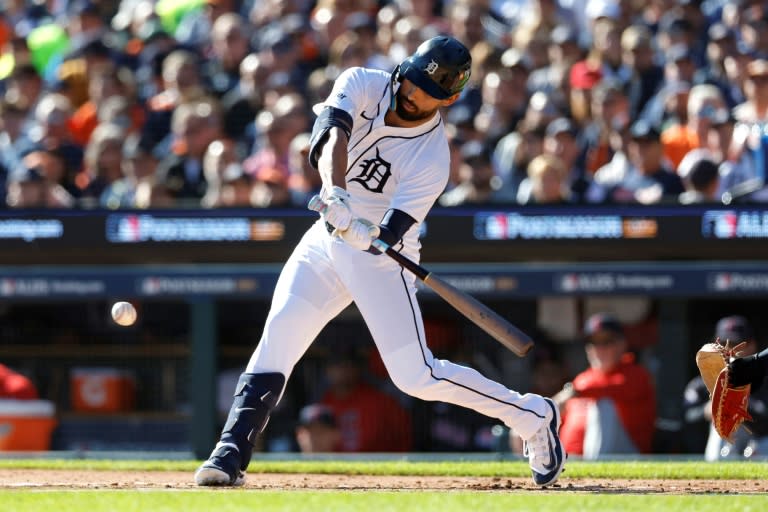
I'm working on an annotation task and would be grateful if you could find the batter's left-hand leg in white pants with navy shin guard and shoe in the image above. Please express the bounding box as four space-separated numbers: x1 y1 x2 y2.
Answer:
195 223 350 486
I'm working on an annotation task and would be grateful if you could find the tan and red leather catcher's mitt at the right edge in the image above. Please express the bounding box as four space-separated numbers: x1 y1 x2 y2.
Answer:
696 339 752 441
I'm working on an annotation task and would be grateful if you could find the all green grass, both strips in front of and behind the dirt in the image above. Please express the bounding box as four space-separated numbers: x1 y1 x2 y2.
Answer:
0 459 768 512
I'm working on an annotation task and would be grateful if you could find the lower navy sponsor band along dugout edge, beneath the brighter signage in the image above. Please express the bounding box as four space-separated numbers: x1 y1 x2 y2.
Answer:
0 262 768 300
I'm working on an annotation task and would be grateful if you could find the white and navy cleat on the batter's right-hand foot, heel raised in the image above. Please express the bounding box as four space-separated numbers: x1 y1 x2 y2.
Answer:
523 398 566 486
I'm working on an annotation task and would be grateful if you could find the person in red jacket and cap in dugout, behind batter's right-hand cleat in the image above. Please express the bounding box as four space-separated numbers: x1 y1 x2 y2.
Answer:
554 313 656 459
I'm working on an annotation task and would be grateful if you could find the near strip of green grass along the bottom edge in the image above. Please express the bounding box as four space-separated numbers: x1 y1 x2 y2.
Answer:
0 490 765 512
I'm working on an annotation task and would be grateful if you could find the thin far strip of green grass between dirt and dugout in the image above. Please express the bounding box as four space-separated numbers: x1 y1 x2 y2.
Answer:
0 459 768 480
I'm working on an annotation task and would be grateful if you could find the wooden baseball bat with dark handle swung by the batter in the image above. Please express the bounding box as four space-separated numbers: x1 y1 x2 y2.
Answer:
309 196 533 357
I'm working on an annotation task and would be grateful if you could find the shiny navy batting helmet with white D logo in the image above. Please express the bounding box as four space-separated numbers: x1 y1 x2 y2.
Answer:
395 36 472 100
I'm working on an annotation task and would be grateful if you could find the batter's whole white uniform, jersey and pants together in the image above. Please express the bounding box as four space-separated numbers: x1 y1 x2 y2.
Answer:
246 68 548 439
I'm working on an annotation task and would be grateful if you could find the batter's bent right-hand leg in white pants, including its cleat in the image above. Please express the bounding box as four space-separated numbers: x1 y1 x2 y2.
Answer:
339 250 565 485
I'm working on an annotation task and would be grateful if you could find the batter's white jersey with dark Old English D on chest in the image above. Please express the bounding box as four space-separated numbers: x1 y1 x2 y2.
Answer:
315 68 450 257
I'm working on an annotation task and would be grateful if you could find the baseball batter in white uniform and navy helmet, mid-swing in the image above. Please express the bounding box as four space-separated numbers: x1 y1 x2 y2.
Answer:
195 36 565 486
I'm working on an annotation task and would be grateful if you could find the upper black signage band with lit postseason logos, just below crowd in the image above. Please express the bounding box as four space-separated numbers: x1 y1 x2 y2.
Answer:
0 204 768 264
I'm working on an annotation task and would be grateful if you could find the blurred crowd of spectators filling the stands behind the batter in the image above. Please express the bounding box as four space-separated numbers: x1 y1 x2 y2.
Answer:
0 0 768 208
